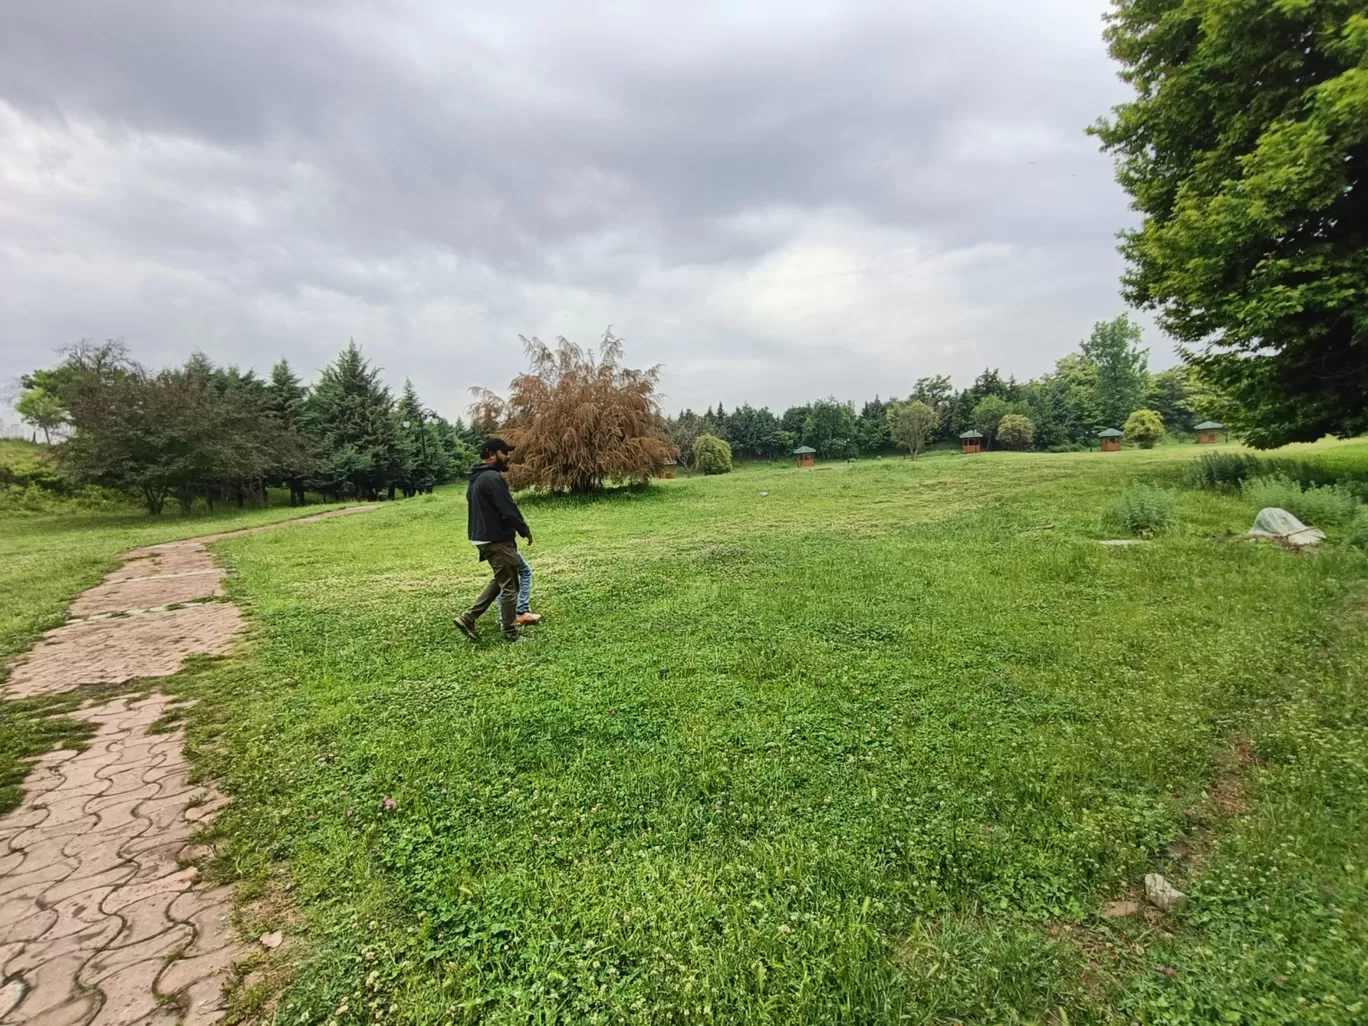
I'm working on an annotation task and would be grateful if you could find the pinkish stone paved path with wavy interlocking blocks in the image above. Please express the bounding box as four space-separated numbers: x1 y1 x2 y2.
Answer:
0 506 369 1026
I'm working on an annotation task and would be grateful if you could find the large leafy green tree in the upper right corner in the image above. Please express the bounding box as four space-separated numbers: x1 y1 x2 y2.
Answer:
1093 0 1368 447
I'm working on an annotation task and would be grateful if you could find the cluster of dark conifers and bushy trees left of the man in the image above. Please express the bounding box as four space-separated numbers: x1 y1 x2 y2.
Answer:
16 341 483 513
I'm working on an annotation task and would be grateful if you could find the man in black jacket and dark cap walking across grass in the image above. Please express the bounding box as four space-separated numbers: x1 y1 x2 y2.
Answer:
456 438 532 642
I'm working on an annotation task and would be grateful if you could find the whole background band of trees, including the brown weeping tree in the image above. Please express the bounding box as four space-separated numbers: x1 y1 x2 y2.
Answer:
10 316 1228 513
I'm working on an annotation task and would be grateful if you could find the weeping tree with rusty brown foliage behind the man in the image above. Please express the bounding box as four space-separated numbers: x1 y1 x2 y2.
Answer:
471 328 679 494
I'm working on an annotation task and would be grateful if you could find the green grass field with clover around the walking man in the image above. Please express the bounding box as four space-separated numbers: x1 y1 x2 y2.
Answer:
0 443 1368 1026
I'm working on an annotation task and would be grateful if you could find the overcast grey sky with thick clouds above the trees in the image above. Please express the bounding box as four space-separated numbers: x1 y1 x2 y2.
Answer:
0 0 1172 426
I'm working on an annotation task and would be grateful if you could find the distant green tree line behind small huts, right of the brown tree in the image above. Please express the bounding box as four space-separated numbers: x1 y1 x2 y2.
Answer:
669 315 1230 465
